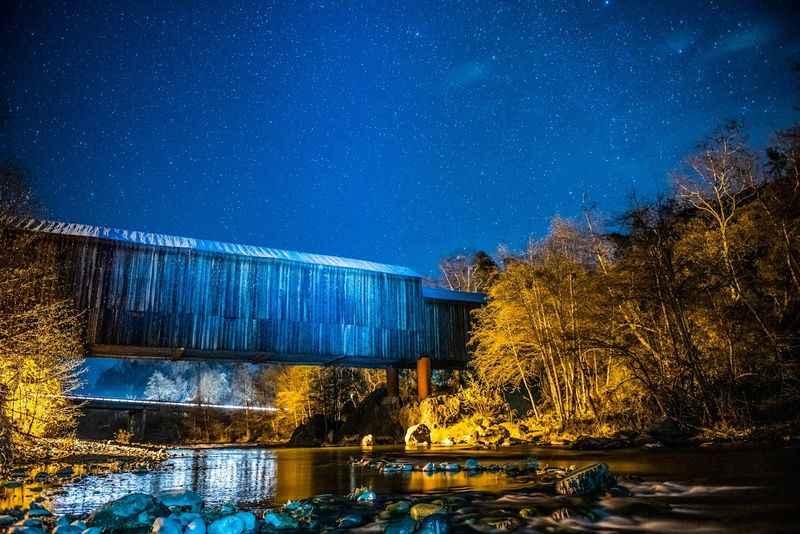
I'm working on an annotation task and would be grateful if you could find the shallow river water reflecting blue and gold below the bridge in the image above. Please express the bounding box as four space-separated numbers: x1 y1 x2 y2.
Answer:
0 448 800 532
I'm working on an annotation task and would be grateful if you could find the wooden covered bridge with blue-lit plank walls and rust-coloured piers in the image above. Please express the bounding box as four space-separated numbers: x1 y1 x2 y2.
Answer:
13 219 485 398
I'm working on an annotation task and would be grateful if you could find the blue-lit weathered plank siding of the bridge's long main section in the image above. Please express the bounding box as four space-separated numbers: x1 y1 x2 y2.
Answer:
55 239 423 361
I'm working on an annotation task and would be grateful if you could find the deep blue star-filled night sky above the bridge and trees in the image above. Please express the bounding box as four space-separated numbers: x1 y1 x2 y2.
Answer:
0 0 800 274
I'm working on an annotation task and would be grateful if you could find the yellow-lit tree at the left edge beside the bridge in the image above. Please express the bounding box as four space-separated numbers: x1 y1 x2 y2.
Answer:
0 163 83 460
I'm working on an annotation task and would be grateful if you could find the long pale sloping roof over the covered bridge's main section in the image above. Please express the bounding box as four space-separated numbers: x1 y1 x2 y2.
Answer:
8 218 420 278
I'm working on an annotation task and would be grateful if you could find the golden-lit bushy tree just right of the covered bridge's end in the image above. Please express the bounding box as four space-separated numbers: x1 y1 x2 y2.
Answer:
472 218 610 424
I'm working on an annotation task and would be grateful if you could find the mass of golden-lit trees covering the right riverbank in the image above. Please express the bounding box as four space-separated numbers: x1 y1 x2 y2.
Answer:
473 126 800 436
